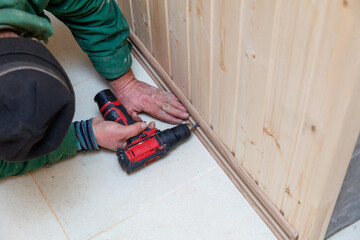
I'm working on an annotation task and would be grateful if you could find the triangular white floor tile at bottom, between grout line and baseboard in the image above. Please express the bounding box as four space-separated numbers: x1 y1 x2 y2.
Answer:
93 169 276 240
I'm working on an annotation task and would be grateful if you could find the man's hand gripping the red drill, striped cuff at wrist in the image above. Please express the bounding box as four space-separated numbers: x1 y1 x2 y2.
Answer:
92 117 155 151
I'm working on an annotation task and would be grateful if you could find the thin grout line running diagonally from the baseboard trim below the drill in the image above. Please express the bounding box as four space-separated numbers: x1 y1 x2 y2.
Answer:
88 166 219 240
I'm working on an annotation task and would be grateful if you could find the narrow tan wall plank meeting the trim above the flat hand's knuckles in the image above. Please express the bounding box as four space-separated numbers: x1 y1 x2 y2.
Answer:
149 0 170 74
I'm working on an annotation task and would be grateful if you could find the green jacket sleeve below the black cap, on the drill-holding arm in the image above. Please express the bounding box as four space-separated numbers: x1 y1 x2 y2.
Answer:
0 124 77 179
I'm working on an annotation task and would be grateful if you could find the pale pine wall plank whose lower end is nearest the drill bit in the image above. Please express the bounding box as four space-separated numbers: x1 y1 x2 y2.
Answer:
188 0 213 122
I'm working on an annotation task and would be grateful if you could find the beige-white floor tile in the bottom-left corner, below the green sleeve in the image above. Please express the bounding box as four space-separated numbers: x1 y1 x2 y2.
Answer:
0 173 66 240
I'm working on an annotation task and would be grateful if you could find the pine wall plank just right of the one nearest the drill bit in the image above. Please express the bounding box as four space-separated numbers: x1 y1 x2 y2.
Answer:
210 0 242 149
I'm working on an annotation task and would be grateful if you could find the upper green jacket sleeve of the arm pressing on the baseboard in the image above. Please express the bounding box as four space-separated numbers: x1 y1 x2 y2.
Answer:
46 0 132 79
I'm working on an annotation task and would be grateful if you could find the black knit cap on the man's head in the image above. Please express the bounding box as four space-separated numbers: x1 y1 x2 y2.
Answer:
0 38 75 162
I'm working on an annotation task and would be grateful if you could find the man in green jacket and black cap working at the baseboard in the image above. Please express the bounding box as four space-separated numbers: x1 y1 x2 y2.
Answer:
0 0 189 178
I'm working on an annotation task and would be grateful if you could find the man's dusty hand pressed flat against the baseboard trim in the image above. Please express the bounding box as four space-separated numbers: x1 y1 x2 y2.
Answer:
109 69 189 124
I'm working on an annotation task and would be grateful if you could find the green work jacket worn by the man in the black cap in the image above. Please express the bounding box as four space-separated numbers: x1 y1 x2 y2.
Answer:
0 0 132 178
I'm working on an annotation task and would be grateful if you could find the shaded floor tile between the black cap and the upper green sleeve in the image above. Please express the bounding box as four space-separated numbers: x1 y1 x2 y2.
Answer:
46 13 99 85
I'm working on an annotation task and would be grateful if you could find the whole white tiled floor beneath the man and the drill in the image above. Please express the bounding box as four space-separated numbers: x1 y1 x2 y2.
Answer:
0 14 275 240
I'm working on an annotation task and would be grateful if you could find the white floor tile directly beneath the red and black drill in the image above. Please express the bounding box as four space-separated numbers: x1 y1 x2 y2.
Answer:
33 72 218 240
